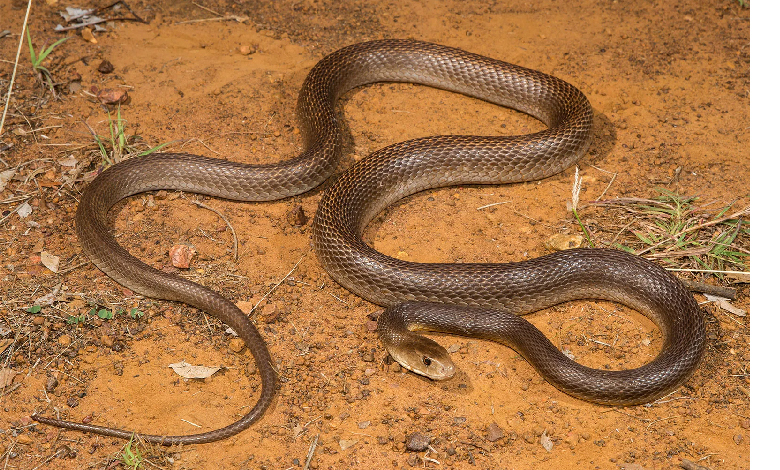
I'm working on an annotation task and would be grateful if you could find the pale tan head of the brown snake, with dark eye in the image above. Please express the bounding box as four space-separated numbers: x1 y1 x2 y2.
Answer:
387 334 455 380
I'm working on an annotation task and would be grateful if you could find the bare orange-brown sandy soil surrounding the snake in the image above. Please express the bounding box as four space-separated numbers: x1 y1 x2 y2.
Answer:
0 0 750 470
